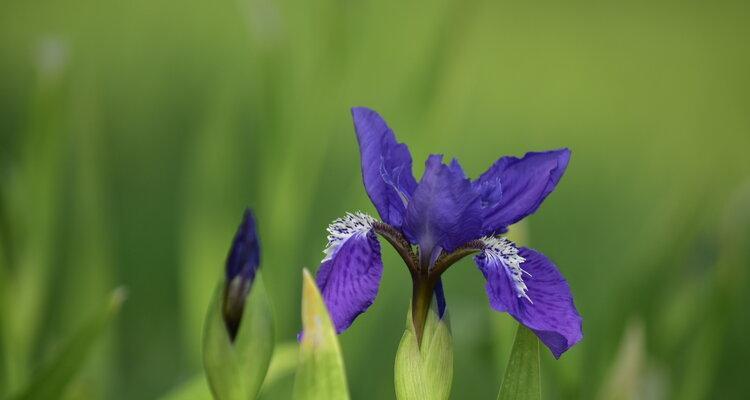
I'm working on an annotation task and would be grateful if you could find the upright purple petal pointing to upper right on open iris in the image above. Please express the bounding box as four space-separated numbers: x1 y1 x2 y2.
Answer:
473 149 570 235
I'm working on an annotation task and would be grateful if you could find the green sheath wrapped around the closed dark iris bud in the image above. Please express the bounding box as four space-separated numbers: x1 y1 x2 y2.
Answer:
203 272 274 400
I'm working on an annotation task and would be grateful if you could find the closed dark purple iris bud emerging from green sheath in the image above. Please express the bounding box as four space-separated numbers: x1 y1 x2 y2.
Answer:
223 209 260 340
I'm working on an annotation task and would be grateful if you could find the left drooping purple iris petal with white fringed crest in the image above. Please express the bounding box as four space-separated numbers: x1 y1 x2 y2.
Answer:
315 214 383 333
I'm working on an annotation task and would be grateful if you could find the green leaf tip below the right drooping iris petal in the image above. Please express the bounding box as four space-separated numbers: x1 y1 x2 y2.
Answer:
497 324 542 400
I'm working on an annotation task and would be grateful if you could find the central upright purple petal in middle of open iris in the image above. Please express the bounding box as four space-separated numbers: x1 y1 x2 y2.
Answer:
403 155 482 253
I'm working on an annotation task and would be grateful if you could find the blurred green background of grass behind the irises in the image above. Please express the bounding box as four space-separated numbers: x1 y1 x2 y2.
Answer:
0 0 750 399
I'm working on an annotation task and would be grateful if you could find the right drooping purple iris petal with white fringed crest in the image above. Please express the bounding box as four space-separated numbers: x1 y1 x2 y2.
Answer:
475 238 583 358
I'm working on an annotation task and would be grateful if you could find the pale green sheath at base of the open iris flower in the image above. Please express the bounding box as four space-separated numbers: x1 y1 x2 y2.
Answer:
394 302 453 400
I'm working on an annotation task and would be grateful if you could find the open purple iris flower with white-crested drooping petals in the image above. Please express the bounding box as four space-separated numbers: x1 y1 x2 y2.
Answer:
316 108 583 358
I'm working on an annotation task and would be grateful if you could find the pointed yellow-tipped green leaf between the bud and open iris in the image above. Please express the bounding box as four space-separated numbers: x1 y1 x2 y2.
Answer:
294 270 349 400
